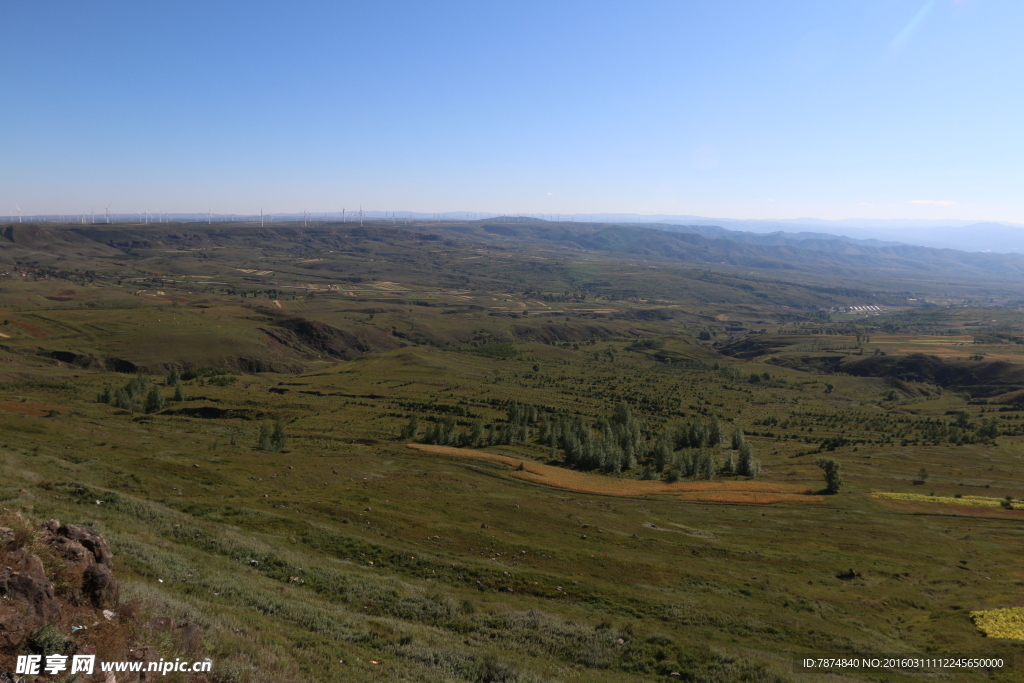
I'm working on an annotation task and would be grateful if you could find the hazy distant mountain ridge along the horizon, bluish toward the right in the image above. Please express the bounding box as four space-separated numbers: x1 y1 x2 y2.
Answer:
6 216 1024 290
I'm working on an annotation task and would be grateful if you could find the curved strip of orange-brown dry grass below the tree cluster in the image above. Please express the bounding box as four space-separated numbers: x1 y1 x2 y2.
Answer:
409 443 823 504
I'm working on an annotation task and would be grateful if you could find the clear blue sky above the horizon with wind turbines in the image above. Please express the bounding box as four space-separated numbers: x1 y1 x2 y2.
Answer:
0 0 1024 222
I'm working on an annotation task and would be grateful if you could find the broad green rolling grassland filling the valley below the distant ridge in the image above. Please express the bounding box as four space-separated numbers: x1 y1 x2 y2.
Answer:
0 223 1024 681
